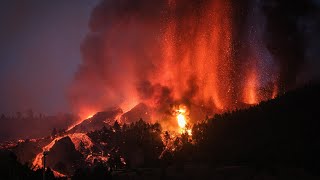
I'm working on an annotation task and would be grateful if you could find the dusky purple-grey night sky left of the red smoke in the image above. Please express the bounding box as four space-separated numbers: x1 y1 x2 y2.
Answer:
0 0 98 114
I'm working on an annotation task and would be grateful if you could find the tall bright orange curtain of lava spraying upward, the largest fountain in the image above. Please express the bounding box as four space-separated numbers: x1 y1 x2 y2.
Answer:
152 0 233 110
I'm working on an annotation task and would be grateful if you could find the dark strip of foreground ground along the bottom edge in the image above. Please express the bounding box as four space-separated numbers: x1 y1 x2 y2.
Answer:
113 165 320 180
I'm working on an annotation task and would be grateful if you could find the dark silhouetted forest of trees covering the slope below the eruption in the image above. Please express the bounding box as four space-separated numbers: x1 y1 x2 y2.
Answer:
1 84 320 179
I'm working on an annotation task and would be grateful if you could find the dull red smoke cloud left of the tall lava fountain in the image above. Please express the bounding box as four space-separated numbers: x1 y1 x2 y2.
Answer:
69 0 218 114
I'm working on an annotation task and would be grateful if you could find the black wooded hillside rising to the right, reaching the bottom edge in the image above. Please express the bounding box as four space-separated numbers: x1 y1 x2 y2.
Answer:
2 84 320 179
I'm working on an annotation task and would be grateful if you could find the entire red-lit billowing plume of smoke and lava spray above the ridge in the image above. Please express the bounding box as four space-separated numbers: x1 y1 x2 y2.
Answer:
70 0 288 124
